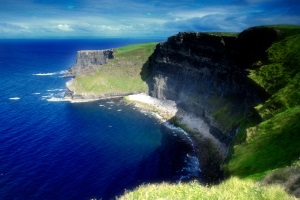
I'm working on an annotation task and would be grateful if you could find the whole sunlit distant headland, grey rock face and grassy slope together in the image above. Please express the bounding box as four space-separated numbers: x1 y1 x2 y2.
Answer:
65 42 157 100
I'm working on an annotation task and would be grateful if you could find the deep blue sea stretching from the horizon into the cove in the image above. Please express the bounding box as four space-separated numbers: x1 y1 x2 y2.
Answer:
0 38 201 200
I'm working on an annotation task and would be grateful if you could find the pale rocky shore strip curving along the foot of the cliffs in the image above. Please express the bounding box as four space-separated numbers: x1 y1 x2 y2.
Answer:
62 93 227 155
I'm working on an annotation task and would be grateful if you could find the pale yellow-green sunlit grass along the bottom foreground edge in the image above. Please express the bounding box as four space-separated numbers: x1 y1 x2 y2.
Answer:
119 178 295 200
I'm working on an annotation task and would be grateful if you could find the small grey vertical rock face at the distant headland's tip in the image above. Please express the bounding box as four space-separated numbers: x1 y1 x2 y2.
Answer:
65 49 113 76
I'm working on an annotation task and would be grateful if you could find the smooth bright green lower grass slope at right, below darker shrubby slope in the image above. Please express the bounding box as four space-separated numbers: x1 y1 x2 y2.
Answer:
225 106 300 180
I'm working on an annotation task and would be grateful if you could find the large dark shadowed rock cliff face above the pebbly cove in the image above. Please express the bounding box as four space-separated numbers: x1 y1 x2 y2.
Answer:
147 28 278 145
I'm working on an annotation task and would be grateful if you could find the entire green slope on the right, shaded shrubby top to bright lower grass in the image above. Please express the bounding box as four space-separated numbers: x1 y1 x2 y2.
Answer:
225 26 300 180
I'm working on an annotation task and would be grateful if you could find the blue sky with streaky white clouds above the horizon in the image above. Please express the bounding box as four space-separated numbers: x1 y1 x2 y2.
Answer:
0 0 300 38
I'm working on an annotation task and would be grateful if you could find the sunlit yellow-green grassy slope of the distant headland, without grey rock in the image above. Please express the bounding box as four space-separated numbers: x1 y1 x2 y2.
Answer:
72 43 157 95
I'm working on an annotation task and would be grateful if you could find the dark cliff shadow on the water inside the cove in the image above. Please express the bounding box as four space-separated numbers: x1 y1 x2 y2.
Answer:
102 123 201 199
